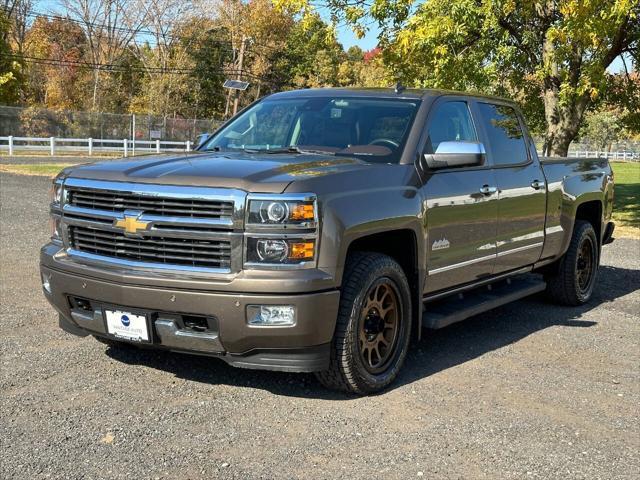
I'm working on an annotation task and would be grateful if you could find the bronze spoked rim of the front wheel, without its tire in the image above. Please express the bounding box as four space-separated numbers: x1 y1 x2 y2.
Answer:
358 277 402 374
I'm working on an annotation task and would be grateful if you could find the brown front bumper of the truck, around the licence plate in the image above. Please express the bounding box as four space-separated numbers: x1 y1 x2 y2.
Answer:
40 248 340 372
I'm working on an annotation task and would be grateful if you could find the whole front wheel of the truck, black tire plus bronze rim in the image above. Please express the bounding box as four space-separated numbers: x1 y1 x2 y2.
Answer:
316 252 412 395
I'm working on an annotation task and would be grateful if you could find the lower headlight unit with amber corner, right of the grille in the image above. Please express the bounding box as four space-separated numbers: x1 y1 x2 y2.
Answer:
247 237 316 266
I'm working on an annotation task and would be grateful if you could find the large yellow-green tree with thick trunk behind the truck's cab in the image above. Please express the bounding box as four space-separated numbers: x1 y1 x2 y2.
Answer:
278 0 640 156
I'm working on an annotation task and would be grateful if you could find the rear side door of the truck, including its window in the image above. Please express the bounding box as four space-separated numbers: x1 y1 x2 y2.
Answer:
475 101 546 273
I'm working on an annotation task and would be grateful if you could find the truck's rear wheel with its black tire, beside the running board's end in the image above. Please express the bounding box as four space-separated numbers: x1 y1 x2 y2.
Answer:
545 220 600 306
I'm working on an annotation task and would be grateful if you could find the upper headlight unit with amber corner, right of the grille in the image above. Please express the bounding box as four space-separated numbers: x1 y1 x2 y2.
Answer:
247 195 318 228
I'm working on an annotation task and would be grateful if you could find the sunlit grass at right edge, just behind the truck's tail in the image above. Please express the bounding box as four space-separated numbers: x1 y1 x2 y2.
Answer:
611 162 640 238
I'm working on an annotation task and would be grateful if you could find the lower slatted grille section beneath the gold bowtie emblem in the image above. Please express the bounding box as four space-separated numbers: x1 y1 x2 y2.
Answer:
69 226 231 270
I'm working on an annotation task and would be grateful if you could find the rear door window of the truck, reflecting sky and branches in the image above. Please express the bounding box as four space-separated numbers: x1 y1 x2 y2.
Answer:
478 103 529 165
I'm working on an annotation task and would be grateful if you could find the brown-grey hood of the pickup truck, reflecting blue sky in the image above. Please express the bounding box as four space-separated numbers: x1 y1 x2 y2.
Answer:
66 152 370 193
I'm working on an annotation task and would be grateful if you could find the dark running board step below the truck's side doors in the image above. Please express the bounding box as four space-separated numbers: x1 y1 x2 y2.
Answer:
422 275 547 329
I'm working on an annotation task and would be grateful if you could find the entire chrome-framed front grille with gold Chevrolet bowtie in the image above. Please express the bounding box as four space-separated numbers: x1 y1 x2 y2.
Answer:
62 179 246 275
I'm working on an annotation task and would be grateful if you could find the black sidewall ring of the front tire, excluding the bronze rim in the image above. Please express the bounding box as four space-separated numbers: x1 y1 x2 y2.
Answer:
348 261 412 392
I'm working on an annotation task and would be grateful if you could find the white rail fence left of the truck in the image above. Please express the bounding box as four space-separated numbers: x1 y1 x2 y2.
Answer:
0 136 192 157
